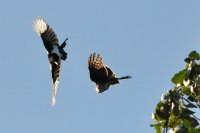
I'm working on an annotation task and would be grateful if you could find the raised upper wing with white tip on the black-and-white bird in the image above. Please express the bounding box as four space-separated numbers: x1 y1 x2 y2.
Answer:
33 18 58 53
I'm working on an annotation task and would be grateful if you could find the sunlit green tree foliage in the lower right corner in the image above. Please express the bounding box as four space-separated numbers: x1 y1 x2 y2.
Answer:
151 51 200 133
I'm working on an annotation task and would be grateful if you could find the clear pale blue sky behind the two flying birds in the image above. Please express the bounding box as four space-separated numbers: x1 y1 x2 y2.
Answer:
0 0 200 133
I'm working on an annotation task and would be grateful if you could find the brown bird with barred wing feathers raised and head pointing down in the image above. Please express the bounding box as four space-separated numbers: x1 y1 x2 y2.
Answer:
88 53 131 93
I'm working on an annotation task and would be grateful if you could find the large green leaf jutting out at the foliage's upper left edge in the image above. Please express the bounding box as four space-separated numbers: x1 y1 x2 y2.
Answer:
171 69 187 85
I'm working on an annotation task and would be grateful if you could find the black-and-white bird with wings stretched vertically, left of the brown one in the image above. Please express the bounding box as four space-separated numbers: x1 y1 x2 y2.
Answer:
33 18 68 106
